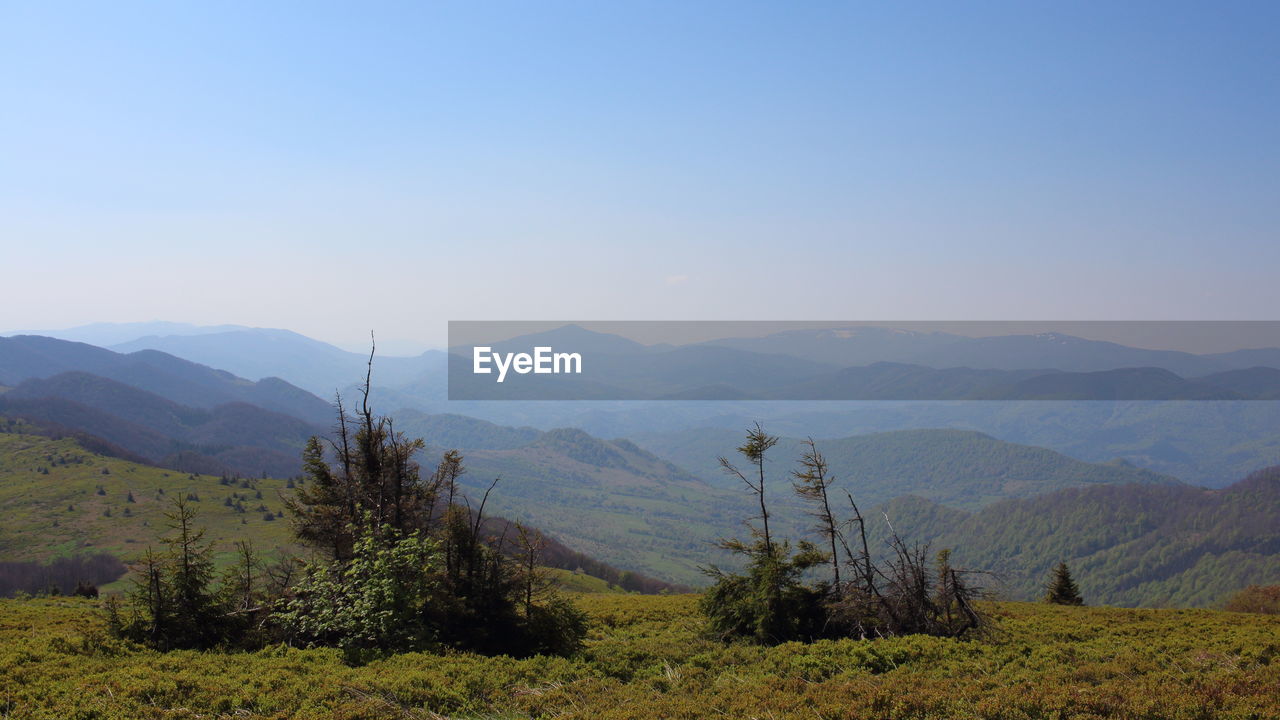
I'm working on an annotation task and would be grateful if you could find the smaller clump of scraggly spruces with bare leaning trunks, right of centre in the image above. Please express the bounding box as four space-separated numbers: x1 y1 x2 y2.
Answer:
701 424 987 644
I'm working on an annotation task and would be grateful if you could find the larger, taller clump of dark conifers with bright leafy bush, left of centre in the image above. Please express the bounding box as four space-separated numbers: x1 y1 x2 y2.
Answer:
279 382 585 656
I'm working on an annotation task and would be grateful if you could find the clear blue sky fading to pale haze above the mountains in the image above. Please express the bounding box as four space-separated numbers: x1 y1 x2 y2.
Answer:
0 0 1280 346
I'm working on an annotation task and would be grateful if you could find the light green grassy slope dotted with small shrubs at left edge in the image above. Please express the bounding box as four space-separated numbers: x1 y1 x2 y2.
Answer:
0 434 289 573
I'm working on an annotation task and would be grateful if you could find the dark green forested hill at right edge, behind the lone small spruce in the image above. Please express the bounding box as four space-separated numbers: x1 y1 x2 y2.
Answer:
872 468 1280 606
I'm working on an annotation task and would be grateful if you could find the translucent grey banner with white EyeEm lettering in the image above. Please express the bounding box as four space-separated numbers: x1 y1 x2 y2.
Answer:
448 320 1280 401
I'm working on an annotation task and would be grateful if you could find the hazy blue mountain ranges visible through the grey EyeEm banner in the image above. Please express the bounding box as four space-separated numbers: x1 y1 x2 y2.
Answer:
449 325 1280 401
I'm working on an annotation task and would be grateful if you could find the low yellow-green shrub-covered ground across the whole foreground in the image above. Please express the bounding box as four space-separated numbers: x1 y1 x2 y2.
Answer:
0 594 1280 720
